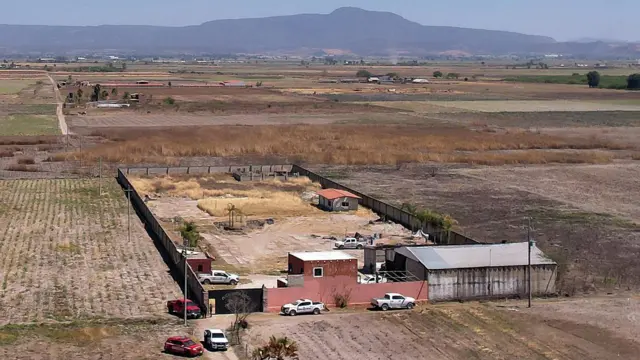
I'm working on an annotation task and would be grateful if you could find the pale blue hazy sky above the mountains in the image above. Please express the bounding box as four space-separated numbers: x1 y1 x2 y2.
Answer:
0 0 640 41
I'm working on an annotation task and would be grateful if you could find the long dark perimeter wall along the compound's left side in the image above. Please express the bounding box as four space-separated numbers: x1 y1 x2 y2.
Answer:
117 169 209 311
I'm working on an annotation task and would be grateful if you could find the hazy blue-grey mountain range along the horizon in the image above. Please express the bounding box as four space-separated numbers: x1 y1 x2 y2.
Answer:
0 7 640 57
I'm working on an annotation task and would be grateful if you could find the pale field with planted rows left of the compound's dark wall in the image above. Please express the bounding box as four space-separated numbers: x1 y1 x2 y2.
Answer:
0 179 181 325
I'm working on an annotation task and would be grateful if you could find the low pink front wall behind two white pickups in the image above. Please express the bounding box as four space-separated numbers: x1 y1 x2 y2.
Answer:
265 278 428 312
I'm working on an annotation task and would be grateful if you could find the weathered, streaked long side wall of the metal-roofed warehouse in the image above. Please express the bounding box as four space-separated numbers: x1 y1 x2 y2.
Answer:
428 259 556 301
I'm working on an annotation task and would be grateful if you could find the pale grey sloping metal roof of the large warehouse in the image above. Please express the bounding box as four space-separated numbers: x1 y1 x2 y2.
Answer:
396 242 555 270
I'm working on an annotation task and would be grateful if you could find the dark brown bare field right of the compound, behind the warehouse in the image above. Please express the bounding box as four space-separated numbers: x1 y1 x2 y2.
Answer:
312 162 640 294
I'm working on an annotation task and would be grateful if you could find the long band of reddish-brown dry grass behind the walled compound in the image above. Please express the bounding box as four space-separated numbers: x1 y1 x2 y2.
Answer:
54 125 626 164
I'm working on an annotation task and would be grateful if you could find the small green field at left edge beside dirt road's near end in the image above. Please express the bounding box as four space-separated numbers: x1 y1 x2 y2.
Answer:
0 115 60 136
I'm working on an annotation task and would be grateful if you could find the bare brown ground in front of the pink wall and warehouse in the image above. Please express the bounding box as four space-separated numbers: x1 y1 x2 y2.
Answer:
239 298 640 360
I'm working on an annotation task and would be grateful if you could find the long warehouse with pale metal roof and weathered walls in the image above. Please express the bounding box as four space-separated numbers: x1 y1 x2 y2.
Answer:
386 242 556 301
